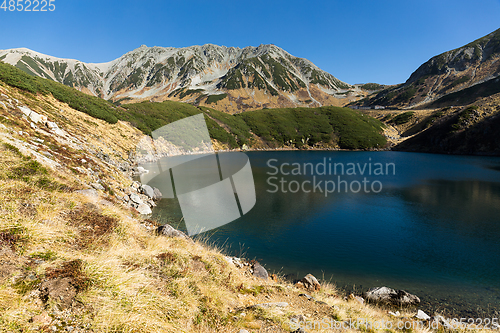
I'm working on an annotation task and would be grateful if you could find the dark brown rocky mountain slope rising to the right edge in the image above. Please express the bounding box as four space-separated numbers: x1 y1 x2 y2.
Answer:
356 29 500 108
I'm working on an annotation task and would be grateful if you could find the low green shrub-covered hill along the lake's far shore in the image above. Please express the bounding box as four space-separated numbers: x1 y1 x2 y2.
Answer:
120 101 386 149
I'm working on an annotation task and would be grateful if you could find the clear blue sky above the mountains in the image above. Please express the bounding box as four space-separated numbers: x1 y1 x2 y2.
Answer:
0 0 500 84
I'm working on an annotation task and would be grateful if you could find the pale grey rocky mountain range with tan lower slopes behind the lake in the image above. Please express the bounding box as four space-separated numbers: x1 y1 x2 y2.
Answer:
0 44 365 113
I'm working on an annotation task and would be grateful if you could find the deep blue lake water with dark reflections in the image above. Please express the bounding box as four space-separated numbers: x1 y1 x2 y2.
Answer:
153 151 500 317
